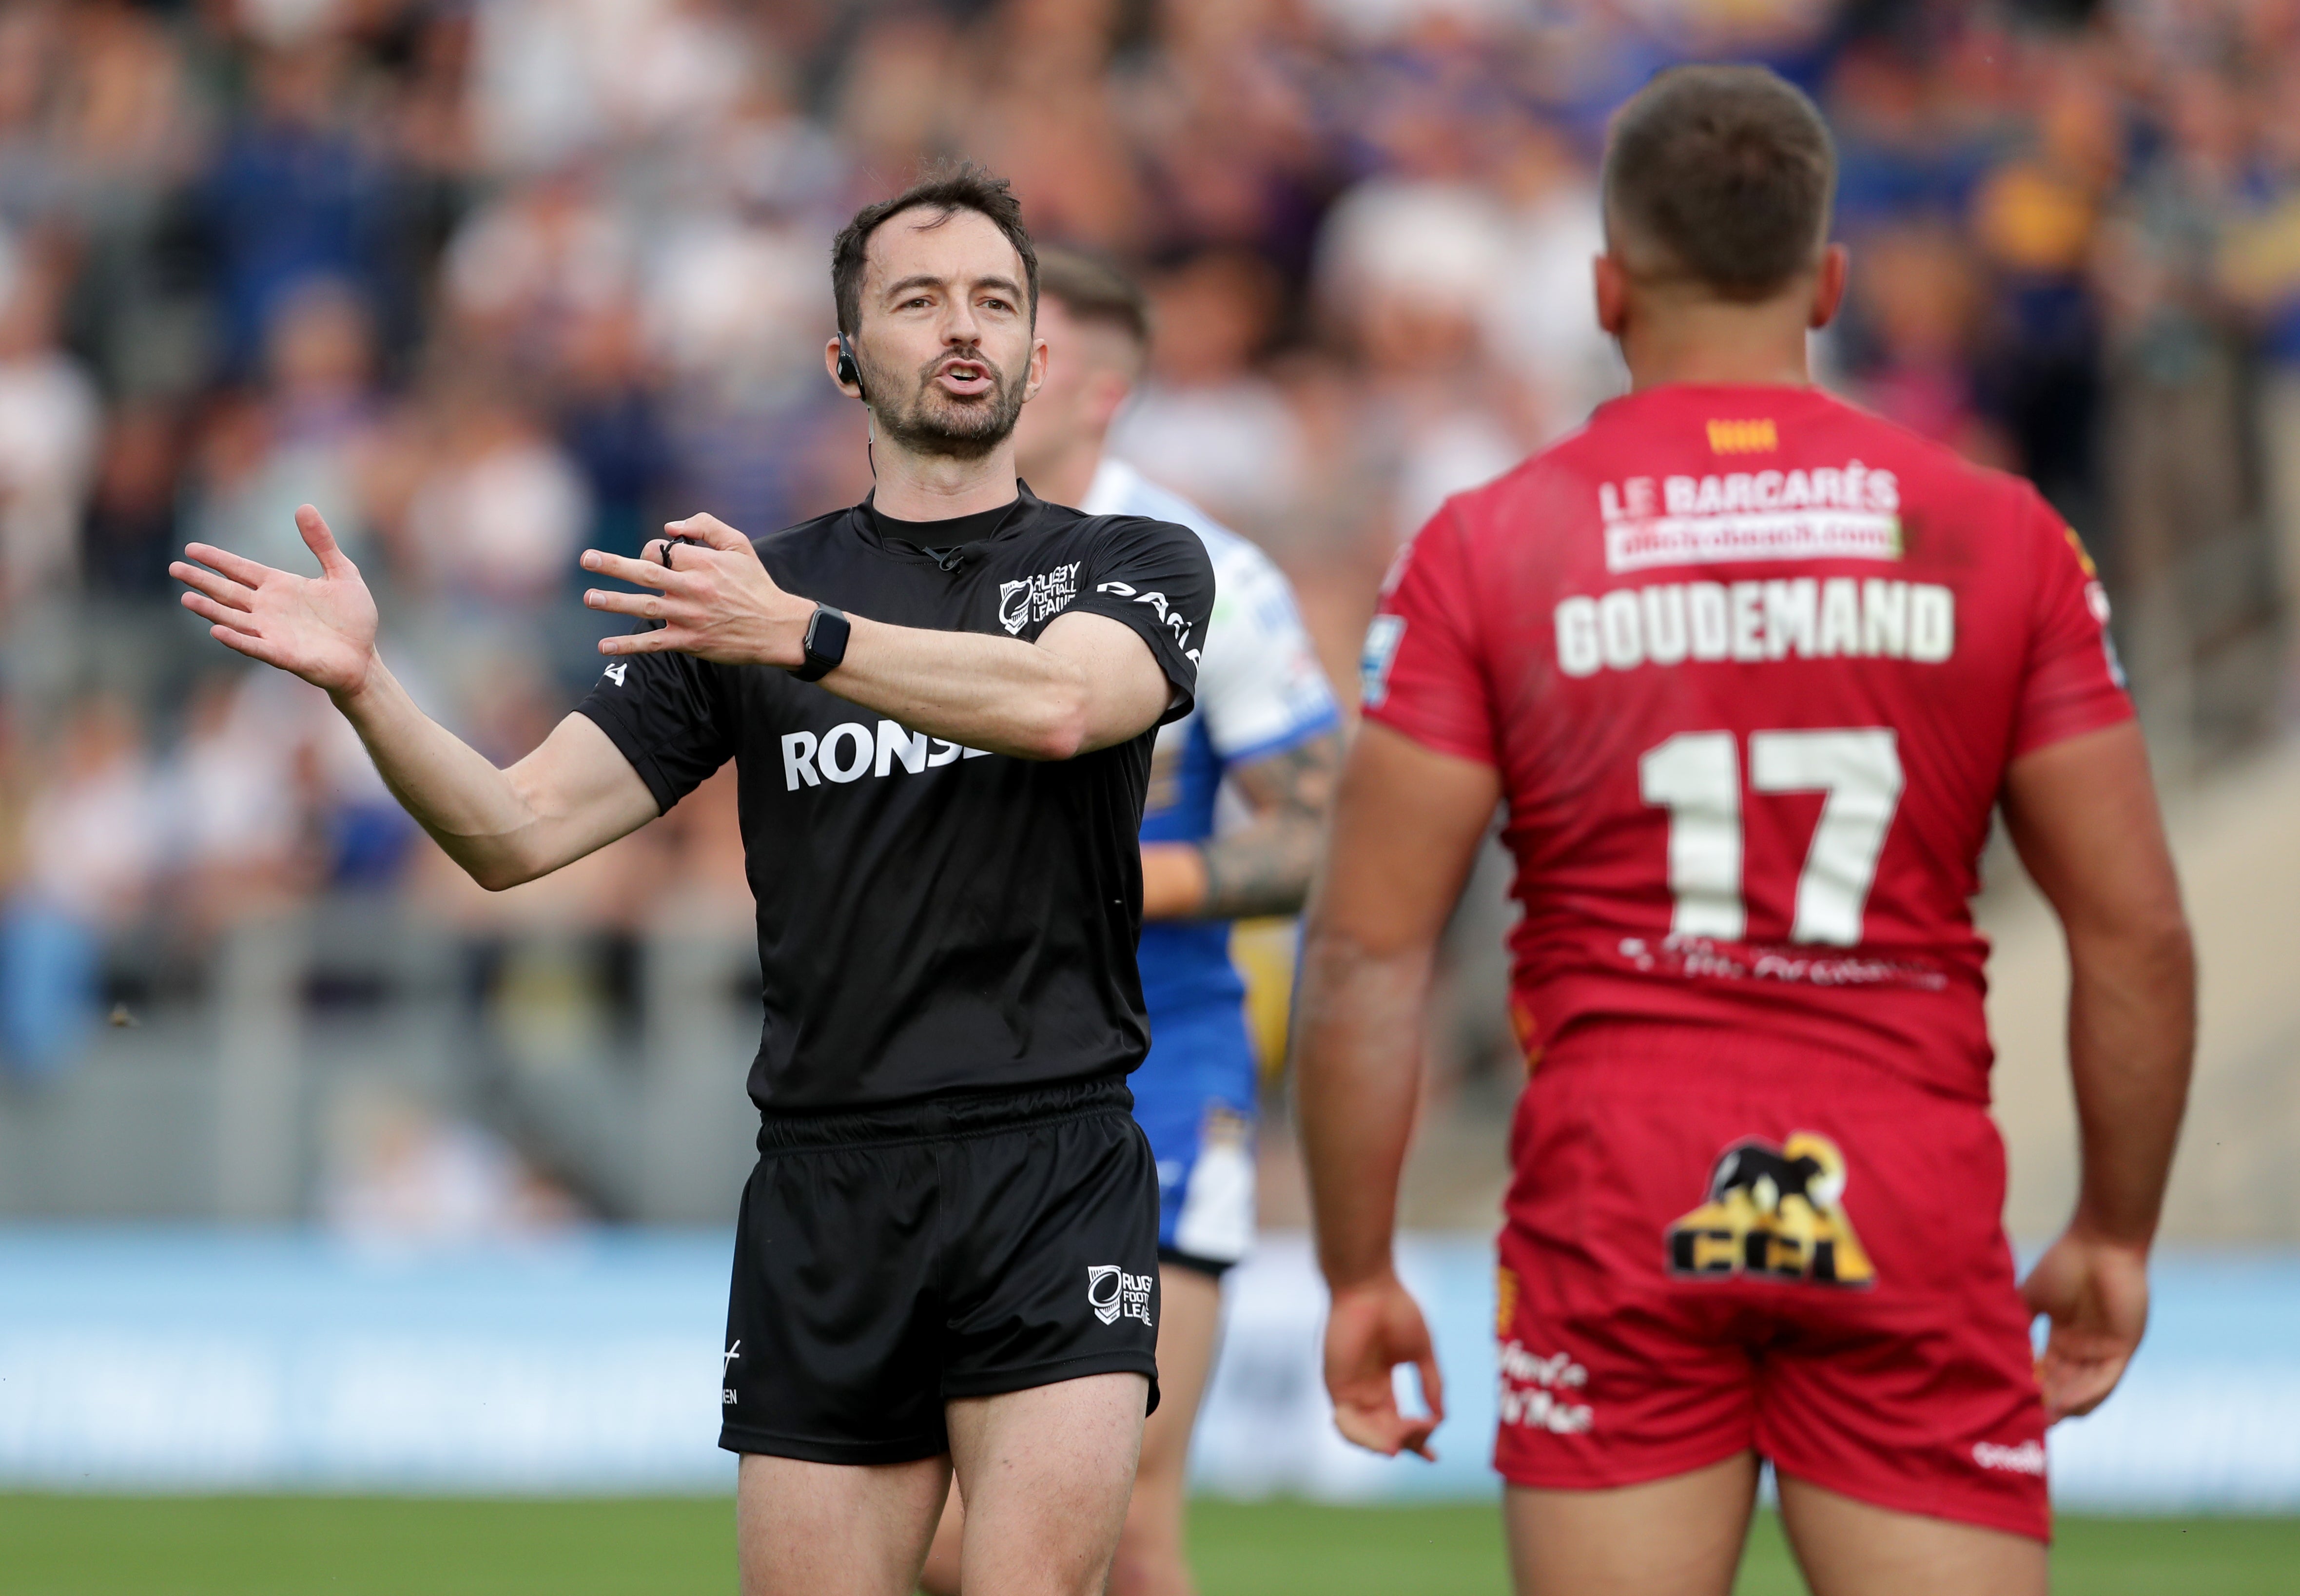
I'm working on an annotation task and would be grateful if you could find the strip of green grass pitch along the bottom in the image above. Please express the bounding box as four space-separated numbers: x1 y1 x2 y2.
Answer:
0 1495 2300 1596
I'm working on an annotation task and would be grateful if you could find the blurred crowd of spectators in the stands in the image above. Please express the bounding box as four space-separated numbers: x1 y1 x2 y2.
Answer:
0 0 2300 1090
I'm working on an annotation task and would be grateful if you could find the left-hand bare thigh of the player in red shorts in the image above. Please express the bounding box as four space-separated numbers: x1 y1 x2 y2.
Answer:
1502 1454 1757 1596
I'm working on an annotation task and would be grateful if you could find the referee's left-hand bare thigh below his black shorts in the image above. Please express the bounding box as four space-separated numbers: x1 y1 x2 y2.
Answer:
736 1454 950 1596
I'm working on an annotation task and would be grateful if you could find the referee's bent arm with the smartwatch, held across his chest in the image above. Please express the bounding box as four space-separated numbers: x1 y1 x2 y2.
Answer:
582 515 1173 759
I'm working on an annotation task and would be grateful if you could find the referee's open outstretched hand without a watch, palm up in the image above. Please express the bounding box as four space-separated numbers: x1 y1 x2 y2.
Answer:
168 504 375 699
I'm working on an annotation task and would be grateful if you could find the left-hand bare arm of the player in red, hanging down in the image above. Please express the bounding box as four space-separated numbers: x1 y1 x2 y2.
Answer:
1295 722 1500 1456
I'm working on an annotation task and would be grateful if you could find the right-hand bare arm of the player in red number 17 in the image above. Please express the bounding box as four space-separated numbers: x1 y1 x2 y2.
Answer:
2003 720 2197 1419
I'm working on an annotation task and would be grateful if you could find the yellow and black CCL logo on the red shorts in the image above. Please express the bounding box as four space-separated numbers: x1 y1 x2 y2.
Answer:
1668 1131 1877 1285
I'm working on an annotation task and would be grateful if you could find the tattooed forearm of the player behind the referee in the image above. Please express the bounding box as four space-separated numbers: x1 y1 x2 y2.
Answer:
1143 731 1341 920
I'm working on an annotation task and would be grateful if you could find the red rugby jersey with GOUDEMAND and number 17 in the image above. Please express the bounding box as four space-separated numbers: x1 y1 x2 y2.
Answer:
1364 384 2132 1099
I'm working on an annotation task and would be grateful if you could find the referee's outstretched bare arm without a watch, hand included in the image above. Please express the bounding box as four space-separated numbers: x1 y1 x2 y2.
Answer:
168 504 656 890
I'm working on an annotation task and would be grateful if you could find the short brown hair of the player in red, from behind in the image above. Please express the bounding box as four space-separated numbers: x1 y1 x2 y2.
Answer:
1605 67 1838 304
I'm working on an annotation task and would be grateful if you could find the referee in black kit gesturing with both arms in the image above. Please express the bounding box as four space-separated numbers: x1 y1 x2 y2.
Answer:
173 166 1214 1596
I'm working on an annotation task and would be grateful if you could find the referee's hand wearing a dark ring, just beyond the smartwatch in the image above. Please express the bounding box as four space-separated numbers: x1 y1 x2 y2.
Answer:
582 515 814 669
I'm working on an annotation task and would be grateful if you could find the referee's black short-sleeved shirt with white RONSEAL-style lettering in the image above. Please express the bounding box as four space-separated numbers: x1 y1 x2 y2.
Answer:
577 487 1214 1111
